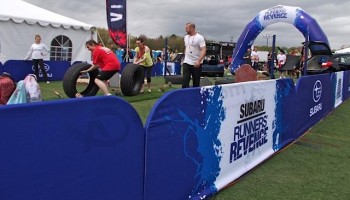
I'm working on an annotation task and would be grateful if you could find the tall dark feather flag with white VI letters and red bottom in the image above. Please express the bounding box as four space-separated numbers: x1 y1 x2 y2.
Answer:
106 0 127 48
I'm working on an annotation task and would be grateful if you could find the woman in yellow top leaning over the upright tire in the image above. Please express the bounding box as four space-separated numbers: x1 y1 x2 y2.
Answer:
134 37 153 93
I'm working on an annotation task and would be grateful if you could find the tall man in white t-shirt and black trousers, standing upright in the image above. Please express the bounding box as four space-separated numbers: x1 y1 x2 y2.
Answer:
182 22 206 88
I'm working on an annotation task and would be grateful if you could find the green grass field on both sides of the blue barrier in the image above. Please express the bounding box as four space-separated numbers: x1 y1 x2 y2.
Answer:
40 77 350 200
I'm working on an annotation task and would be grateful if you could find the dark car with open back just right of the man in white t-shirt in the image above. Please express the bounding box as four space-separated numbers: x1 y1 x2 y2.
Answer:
201 43 225 77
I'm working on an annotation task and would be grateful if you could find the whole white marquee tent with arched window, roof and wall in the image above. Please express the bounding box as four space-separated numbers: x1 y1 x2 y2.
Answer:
0 0 97 63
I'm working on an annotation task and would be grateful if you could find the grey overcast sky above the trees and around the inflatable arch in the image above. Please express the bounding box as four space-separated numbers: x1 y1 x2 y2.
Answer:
23 0 350 49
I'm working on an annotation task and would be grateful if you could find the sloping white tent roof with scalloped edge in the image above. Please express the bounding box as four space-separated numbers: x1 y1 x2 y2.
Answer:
0 0 94 30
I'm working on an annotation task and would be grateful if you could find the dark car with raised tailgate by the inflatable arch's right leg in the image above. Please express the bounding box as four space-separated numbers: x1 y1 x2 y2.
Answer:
302 41 339 74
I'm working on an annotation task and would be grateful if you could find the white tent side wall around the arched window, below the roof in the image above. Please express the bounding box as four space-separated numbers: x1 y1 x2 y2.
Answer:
0 20 97 63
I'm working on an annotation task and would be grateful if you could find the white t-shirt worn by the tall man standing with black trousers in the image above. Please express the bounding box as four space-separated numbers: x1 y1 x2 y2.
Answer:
184 33 206 65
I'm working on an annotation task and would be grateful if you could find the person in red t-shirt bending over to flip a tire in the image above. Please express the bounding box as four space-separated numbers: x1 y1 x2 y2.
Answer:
76 40 120 97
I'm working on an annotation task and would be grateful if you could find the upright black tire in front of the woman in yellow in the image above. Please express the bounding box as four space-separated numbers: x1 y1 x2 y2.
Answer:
120 63 144 96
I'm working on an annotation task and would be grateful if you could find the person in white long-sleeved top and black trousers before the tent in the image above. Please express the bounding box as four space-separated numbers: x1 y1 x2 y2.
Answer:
24 35 50 83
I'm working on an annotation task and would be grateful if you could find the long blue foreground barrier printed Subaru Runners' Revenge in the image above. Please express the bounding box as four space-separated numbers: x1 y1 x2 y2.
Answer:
0 71 350 200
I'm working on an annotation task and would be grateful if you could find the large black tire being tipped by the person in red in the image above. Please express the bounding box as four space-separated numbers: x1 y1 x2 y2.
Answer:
63 63 99 98
